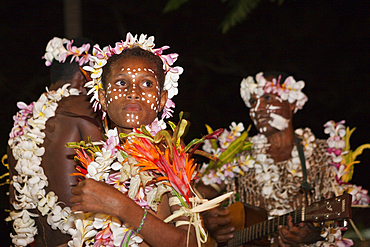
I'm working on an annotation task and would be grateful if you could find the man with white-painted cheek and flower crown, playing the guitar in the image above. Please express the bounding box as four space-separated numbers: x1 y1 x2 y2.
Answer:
198 73 369 246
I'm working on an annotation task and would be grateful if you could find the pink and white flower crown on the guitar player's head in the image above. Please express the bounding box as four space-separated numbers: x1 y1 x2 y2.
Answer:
240 72 308 113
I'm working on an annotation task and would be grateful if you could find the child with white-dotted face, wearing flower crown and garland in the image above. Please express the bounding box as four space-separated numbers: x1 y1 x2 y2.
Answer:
70 34 208 246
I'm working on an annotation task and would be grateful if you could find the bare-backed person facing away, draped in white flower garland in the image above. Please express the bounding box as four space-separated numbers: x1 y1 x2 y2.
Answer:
8 37 102 247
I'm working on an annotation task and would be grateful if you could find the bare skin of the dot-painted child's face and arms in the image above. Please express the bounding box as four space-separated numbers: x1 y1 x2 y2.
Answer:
70 57 197 247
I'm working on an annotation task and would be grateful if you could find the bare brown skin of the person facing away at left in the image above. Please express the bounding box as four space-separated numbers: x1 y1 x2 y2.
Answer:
8 69 102 247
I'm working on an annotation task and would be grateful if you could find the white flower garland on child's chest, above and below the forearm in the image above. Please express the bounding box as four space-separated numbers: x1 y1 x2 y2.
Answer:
62 128 175 247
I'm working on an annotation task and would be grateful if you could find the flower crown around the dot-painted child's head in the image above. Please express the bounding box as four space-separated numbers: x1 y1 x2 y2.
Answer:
83 33 184 113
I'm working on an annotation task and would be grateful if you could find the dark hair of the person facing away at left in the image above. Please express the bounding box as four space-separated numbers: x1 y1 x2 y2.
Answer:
50 37 94 84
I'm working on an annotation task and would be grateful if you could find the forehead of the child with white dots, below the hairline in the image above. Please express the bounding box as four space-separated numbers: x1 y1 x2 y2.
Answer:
112 57 157 75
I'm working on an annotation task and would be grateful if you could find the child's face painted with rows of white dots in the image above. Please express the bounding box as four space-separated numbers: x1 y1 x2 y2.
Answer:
105 58 165 132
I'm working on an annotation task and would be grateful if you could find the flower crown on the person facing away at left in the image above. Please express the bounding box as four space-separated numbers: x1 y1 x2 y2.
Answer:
42 37 91 66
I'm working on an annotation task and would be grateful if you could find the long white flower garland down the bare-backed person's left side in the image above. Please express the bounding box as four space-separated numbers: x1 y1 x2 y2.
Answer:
7 84 79 246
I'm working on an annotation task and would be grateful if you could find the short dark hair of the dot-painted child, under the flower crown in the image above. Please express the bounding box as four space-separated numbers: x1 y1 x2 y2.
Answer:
102 46 165 91
